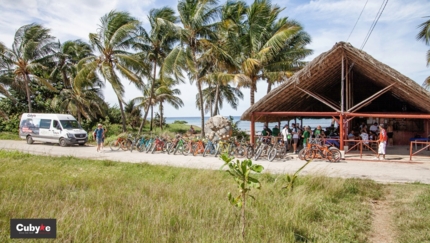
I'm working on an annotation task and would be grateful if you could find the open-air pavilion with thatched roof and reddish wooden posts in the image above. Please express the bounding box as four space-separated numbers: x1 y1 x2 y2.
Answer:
241 42 430 150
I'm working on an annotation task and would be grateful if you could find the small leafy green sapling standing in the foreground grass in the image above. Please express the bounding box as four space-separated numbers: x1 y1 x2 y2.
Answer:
221 153 264 242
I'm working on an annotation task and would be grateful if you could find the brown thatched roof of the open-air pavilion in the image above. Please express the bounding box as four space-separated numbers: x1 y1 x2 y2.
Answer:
241 42 430 121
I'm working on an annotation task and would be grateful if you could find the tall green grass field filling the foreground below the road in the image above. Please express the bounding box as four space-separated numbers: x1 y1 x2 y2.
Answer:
0 151 430 242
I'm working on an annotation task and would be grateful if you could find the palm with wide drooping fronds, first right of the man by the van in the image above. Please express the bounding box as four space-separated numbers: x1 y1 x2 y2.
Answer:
77 11 145 132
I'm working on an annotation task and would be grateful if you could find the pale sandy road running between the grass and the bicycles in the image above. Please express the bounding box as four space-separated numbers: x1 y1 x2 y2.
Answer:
0 140 430 184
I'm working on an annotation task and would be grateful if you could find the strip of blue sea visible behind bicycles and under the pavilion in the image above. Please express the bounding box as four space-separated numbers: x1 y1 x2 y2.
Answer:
166 116 332 132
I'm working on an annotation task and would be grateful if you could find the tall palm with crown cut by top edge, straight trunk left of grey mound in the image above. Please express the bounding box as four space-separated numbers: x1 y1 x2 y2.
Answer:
164 0 220 137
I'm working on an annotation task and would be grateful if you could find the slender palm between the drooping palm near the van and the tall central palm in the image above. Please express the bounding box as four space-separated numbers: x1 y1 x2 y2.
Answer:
134 7 178 134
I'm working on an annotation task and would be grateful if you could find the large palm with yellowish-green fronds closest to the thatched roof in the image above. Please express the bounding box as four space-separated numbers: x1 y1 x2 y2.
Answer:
238 0 308 105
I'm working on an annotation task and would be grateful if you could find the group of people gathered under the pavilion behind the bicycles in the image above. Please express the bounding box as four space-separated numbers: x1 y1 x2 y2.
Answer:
261 123 326 154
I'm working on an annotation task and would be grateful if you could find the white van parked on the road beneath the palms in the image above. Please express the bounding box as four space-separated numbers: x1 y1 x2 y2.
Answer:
19 113 88 147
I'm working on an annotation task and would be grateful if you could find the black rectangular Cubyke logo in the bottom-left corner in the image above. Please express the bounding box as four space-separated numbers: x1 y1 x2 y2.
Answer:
10 219 57 239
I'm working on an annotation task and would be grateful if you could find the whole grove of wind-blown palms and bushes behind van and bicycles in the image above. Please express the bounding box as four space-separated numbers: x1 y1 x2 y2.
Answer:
0 0 312 135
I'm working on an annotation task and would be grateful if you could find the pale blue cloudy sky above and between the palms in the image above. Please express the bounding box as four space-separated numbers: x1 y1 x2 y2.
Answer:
0 0 430 117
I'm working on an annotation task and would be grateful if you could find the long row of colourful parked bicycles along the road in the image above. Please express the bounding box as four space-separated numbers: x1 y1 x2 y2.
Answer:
109 135 341 162
